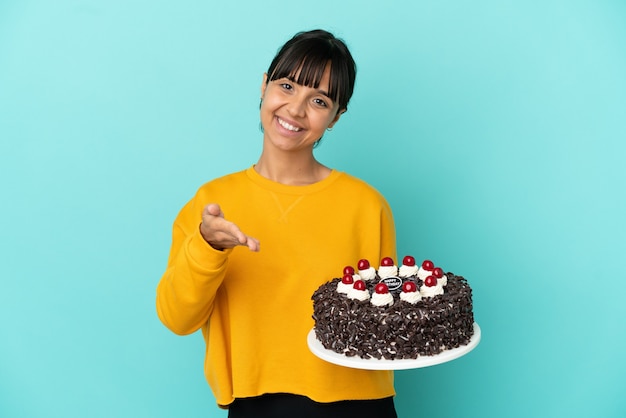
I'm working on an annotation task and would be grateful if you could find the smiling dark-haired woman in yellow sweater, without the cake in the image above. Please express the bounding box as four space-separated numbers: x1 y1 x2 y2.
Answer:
157 30 396 418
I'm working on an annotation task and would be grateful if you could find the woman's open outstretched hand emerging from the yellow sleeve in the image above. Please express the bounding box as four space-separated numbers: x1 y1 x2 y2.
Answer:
200 203 260 251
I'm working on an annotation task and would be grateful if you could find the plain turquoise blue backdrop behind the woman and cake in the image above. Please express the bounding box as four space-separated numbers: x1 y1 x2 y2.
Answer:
0 0 626 417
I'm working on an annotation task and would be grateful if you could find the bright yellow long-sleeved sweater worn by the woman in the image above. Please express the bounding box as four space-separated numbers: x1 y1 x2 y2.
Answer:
156 167 396 406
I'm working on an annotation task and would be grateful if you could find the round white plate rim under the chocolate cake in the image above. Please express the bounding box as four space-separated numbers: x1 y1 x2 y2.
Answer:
307 322 480 370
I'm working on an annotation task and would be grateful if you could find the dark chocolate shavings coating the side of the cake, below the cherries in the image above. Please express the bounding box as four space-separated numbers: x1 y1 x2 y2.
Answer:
312 273 474 360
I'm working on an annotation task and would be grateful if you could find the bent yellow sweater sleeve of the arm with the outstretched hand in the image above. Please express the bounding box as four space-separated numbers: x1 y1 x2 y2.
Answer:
156 198 232 335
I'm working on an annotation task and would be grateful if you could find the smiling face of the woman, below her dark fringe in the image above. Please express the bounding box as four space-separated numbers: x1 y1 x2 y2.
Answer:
261 66 341 151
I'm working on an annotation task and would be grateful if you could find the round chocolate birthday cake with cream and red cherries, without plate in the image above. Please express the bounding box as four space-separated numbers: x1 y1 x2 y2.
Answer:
312 256 474 360
